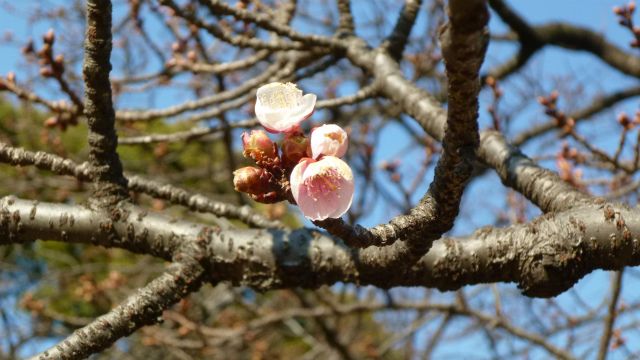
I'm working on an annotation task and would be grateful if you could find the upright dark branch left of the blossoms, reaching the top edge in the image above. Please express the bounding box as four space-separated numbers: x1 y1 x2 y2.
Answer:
82 0 128 206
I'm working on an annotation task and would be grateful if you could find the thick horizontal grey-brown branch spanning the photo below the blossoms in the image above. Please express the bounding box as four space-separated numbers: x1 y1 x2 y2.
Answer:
0 197 640 297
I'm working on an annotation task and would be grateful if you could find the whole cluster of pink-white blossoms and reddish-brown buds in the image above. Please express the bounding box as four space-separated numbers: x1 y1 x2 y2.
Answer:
233 83 354 220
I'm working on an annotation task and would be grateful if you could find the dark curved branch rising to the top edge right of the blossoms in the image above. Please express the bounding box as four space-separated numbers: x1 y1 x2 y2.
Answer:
315 0 489 253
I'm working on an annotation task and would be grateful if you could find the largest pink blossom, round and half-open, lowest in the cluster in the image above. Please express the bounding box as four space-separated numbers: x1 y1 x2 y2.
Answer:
290 156 354 220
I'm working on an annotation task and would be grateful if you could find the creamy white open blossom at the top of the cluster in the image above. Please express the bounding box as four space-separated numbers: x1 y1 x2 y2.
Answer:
255 82 316 133
